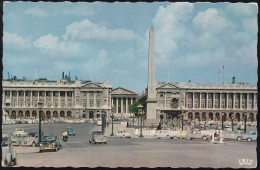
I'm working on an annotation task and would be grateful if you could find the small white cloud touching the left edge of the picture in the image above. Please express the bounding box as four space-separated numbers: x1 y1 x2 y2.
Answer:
3 32 31 49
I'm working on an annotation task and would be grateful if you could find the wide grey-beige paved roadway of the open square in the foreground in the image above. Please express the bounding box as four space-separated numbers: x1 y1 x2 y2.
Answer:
3 123 256 168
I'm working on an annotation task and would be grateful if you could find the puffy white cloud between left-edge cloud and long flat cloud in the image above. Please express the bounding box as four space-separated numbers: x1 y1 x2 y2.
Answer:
33 34 80 57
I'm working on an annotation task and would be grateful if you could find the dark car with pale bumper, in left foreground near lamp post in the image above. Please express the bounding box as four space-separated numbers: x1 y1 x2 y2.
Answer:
40 135 62 152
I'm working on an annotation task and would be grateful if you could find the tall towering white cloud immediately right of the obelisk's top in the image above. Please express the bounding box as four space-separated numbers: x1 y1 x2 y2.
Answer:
152 3 193 57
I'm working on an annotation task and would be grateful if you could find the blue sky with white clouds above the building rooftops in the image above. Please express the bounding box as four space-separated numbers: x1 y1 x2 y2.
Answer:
3 2 258 93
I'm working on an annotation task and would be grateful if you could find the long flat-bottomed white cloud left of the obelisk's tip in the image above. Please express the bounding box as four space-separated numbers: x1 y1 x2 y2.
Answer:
64 19 137 42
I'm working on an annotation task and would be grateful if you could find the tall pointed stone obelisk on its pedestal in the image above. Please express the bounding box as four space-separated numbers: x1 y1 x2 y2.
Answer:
146 27 157 124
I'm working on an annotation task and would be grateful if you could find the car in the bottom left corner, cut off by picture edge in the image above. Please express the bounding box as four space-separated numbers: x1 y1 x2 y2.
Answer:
1 137 16 166
